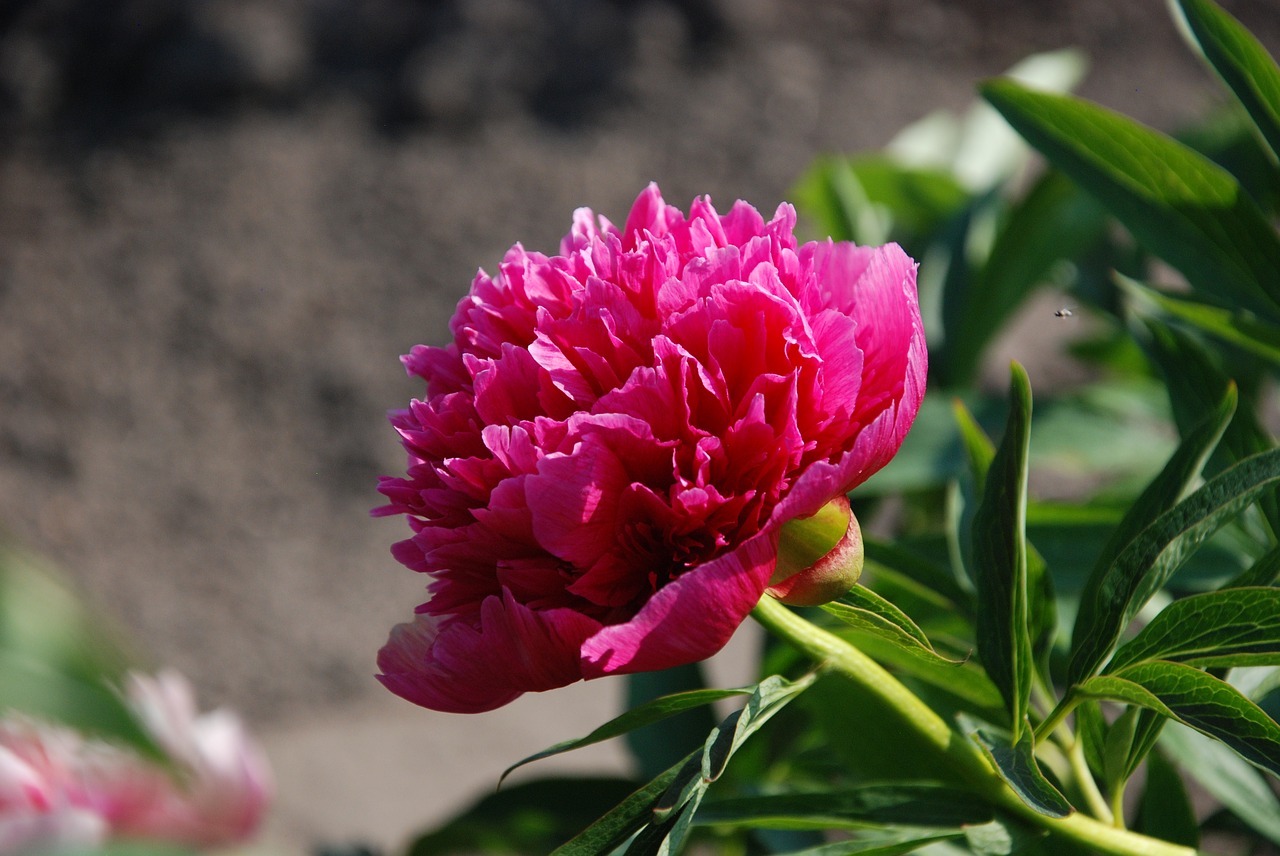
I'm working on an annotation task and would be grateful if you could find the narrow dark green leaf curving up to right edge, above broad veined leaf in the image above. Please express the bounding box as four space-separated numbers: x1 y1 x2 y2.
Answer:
1069 450 1280 683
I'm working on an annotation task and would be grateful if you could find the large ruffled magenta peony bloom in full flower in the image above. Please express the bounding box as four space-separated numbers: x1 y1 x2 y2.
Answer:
375 184 925 713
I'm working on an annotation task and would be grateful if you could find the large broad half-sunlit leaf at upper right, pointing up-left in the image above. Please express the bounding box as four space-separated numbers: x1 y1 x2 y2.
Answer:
980 81 1280 319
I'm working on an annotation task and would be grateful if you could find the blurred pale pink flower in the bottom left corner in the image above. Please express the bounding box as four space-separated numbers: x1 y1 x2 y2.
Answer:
0 672 270 856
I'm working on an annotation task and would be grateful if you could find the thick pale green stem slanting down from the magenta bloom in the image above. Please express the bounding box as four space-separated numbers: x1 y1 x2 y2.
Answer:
751 596 1196 856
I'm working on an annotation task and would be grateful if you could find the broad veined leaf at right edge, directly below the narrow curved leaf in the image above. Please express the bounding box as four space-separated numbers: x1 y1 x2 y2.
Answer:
1106 589 1280 672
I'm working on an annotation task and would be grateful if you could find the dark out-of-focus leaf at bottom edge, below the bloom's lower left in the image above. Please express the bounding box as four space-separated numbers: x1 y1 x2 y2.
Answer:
407 778 645 856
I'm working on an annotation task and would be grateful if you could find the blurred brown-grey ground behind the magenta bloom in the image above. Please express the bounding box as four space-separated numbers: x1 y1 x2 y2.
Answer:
0 0 1280 853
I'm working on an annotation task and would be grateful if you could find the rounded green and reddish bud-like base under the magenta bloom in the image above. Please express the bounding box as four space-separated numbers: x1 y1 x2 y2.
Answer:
767 496 863 606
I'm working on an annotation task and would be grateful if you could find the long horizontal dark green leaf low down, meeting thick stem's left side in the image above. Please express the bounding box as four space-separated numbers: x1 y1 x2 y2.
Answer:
698 782 995 829
